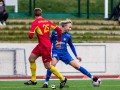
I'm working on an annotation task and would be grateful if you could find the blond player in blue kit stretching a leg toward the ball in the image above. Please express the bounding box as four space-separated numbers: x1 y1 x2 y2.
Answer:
42 19 98 88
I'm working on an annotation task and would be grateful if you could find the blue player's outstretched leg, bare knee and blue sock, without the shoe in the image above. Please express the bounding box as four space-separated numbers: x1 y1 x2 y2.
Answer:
69 60 93 79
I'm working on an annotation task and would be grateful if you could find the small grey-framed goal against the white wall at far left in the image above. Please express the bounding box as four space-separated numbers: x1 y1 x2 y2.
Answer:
0 48 27 76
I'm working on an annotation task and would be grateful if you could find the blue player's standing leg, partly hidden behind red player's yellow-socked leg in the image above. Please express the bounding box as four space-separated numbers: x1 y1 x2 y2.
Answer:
42 58 58 88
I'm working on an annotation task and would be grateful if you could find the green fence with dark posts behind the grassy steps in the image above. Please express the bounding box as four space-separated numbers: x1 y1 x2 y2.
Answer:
7 0 120 17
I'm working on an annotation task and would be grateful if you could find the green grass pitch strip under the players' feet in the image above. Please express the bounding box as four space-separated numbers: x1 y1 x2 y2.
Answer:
0 79 120 90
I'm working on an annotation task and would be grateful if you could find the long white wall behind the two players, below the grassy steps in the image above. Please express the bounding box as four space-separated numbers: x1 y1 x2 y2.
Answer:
0 43 120 76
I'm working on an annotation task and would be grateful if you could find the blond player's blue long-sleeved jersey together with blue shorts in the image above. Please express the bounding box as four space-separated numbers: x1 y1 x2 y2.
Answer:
50 30 77 64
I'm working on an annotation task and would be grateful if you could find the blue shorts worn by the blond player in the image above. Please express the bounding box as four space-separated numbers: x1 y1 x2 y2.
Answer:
52 50 73 64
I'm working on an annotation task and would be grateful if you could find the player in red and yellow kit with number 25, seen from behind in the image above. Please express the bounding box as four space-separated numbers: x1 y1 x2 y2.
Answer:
24 8 67 88
